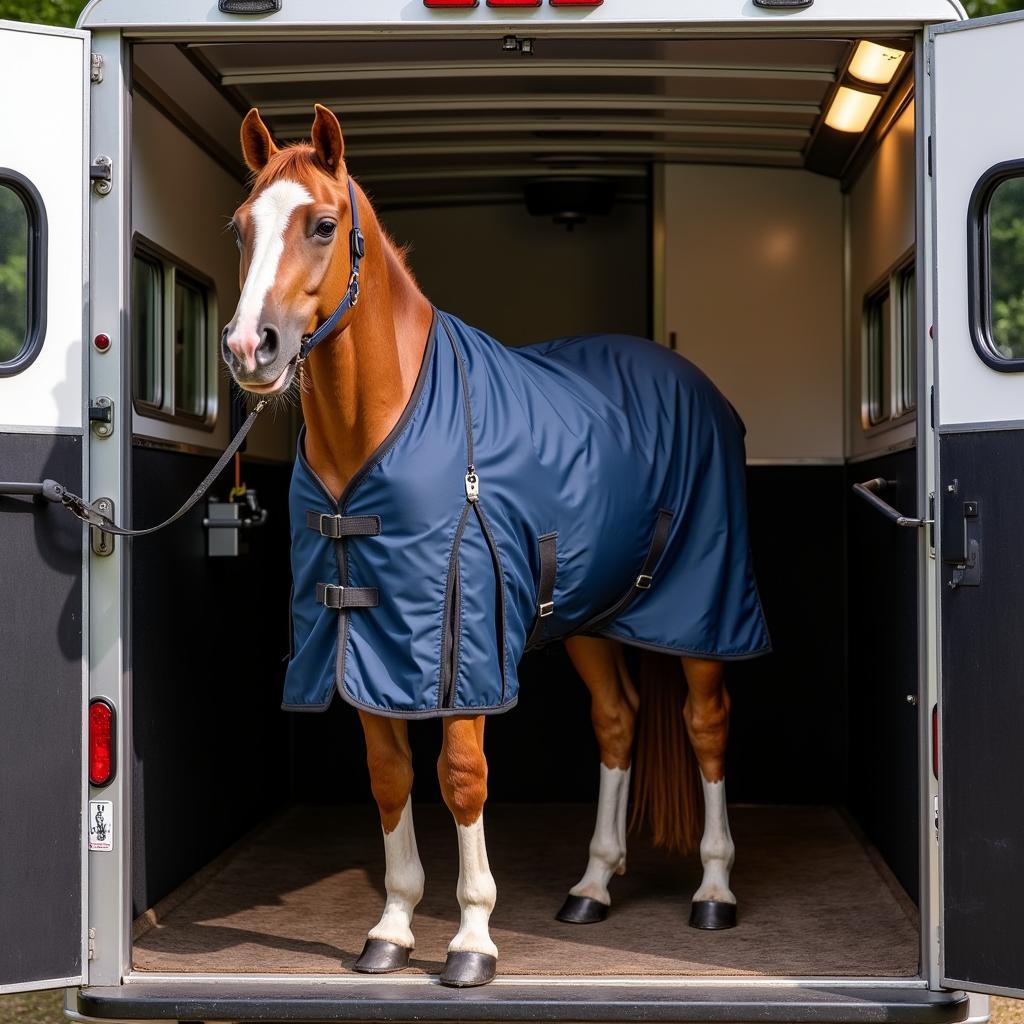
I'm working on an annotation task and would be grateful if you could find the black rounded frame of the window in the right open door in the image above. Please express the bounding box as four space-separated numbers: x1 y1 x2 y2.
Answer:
967 159 1024 374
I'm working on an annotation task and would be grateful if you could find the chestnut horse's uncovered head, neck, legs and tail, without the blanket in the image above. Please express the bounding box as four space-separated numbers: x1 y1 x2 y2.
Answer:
223 105 735 986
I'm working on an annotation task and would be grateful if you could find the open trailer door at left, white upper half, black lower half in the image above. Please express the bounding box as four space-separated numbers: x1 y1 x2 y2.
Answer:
0 22 90 992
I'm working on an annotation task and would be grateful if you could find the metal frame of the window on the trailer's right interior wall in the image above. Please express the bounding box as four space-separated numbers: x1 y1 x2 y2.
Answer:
860 248 921 437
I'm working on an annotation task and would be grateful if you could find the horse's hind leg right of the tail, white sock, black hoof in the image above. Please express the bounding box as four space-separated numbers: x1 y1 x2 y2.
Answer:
683 657 736 930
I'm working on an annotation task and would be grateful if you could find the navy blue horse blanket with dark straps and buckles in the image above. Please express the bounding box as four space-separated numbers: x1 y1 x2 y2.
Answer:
285 312 769 718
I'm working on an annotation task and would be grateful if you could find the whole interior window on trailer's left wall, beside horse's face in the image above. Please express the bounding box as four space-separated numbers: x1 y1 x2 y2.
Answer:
131 239 217 429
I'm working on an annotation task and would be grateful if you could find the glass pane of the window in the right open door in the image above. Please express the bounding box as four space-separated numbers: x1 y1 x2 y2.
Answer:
986 175 1024 359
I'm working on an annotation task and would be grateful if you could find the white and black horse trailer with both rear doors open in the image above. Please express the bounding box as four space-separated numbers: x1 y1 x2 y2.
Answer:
0 0 1024 1024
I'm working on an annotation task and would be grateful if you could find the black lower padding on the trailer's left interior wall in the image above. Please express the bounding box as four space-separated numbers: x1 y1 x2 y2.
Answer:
130 447 291 914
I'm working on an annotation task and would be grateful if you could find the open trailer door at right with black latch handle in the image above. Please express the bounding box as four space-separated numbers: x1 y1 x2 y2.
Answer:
929 8 1024 995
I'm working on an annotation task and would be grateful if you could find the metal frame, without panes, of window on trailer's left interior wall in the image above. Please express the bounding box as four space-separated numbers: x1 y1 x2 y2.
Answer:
128 232 219 432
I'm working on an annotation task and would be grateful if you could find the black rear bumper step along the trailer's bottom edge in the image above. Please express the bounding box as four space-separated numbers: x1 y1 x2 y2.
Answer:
78 978 969 1024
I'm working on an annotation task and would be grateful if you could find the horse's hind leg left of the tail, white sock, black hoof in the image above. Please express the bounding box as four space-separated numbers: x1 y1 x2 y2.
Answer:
555 637 637 925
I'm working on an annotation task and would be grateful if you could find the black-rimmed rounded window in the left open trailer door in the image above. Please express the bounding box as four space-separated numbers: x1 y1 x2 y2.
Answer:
0 168 46 377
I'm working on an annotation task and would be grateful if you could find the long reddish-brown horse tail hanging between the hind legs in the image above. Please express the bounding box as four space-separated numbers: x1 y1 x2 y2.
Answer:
630 651 703 854
